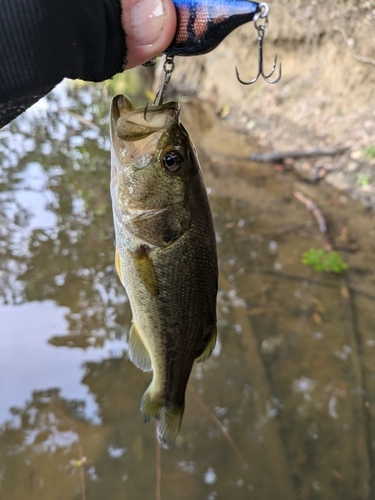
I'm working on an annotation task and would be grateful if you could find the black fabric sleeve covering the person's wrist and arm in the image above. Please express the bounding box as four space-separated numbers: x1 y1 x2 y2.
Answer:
0 0 126 128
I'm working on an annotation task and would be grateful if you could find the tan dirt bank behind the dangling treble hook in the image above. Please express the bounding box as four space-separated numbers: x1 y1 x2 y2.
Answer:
159 0 375 208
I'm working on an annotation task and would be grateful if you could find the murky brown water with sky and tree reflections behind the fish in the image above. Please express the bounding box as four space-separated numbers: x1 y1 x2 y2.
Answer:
0 80 375 500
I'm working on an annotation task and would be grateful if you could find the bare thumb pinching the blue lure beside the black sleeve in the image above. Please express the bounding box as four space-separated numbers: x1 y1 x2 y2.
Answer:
121 0 177 69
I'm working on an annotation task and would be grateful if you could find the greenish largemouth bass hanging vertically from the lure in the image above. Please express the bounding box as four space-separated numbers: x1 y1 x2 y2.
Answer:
110 95 218 448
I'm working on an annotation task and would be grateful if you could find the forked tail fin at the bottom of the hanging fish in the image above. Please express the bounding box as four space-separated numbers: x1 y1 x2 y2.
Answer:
141 384 185 449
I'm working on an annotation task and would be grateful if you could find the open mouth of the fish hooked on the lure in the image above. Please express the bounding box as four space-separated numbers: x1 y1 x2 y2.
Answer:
111 94 180 142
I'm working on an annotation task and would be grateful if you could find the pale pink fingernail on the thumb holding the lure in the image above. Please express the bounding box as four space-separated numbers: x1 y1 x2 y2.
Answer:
132 0 164 45
